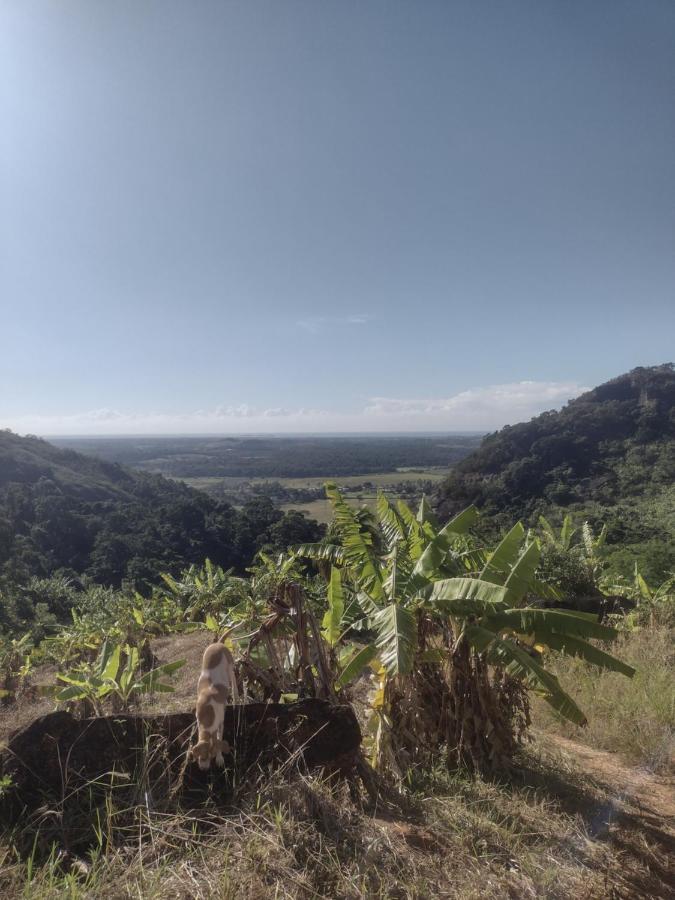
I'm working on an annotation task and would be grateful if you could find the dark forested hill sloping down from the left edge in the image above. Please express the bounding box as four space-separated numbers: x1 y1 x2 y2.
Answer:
0 431 320 586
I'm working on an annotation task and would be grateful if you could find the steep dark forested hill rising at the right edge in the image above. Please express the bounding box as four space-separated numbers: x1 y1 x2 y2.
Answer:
438 364 675 569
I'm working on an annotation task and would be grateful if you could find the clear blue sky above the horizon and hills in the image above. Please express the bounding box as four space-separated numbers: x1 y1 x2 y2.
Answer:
0 0 675 434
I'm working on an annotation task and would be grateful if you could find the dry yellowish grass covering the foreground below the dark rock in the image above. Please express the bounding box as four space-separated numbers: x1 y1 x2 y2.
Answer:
0 760 612 900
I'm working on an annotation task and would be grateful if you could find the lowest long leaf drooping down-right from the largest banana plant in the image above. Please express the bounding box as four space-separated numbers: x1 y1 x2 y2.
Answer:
464 625 586 725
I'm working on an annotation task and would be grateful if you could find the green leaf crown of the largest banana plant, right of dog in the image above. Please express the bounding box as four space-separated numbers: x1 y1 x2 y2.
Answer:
296 484 634 772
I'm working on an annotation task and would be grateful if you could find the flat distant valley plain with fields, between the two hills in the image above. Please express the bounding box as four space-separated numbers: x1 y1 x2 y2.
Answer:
48 434 480 522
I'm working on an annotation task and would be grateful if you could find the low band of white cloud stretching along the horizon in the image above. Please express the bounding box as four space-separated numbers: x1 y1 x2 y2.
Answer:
0 381 588 435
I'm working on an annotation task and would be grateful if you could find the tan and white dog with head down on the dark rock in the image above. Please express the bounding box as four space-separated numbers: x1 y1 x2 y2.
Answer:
190 643 239 770
